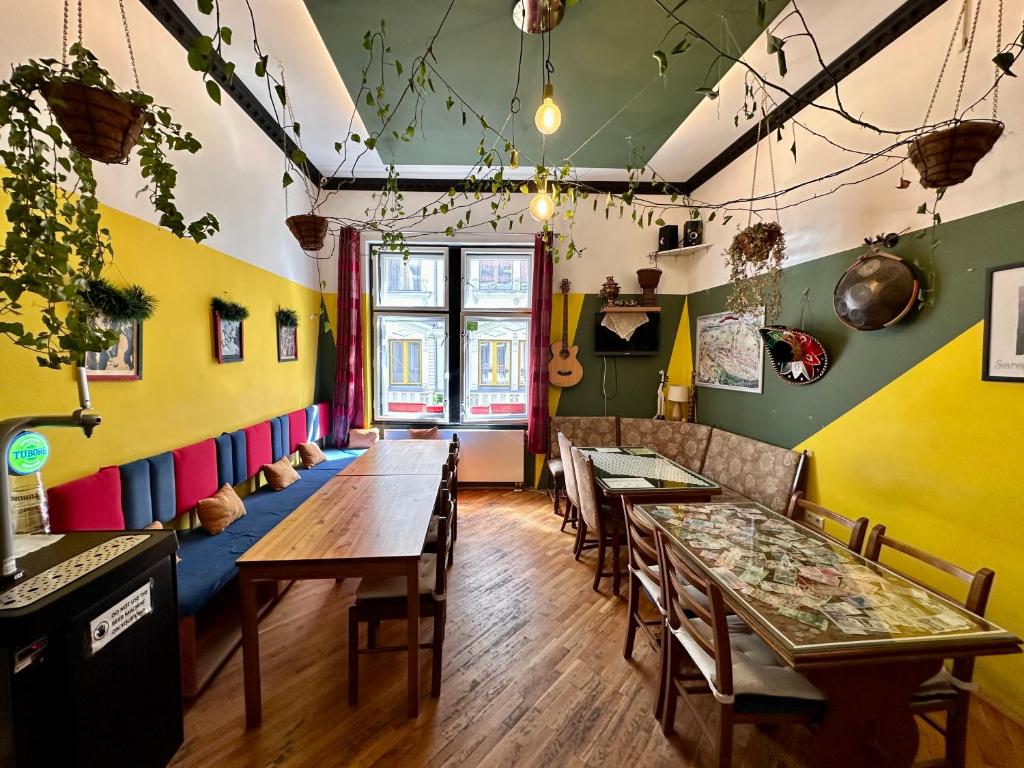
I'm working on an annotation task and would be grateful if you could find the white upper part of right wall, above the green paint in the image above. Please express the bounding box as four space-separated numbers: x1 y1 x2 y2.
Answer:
680 0 1024 291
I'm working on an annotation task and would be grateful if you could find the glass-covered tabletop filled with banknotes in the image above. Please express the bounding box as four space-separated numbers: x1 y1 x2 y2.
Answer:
637 503 1021 669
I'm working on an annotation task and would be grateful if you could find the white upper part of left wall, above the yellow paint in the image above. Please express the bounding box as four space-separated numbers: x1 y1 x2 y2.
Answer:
0 0 319 288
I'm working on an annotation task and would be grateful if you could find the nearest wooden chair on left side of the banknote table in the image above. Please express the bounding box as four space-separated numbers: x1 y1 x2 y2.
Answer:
655 531 825 768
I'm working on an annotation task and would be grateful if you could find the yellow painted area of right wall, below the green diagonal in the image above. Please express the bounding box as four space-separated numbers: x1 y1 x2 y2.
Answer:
797 323 1024 717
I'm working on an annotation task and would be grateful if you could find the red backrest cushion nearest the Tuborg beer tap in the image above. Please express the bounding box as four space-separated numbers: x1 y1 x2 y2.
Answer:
46 467 125 534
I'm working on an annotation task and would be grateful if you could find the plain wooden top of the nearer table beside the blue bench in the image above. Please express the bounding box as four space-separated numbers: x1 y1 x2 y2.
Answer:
238 471 440 567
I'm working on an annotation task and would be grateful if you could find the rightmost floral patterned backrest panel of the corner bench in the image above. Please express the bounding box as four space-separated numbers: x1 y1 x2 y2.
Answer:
701 429 806 514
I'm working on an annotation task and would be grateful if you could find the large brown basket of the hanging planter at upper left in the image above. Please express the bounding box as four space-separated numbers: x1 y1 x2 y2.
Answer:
42 82 145 163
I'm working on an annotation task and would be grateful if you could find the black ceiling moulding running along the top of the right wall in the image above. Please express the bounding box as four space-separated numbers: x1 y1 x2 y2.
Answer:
678 0 947 193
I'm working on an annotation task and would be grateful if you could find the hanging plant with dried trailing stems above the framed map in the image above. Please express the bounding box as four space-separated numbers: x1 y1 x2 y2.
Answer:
725 221 785 323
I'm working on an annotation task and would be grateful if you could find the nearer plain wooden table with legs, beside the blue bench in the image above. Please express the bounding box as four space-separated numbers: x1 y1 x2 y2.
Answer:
238 473 447 728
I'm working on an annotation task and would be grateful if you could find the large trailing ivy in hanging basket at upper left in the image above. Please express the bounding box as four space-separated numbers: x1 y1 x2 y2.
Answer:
0 43 218 369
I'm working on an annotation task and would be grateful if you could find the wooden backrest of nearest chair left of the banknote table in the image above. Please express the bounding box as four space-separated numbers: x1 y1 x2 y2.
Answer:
654 530 733 696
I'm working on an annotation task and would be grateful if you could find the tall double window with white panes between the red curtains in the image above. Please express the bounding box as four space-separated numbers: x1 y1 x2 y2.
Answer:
371 246 532 423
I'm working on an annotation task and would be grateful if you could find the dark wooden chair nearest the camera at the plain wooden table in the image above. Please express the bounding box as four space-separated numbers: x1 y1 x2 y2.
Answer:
348 501 449 706
